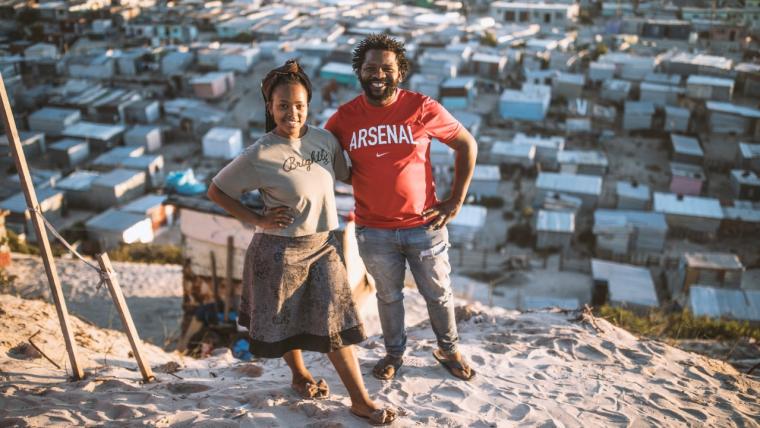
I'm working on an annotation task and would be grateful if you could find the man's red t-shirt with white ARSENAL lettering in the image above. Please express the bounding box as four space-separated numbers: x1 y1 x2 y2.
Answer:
325 89 462 229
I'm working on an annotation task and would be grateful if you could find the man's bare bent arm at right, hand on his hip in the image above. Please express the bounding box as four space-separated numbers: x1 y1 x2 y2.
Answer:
422 127 478 229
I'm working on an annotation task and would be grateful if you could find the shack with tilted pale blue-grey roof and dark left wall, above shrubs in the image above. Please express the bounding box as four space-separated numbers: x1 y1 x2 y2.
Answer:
591 259 660 309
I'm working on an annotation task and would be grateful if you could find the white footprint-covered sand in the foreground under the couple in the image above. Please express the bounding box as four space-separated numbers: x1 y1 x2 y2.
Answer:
0 264 760 427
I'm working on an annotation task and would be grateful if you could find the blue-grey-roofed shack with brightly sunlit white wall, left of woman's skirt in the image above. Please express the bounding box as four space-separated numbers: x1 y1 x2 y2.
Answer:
84 208 154 251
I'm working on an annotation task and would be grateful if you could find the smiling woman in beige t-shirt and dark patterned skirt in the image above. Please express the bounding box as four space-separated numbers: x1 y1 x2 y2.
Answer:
208 60 396 424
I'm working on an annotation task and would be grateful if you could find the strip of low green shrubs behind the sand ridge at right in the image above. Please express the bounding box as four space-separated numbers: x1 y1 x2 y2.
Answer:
594 305 760 340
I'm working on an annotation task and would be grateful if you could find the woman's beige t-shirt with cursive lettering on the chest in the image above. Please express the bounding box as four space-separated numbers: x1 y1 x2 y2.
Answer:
212 126 349 236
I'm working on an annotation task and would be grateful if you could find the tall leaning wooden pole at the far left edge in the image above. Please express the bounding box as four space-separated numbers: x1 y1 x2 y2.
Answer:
0 74 84 380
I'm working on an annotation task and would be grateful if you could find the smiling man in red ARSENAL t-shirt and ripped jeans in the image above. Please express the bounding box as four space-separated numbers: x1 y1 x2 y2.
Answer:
325 34 477 380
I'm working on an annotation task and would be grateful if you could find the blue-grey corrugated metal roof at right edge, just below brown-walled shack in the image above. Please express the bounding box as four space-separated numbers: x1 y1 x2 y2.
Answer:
689 285 760 321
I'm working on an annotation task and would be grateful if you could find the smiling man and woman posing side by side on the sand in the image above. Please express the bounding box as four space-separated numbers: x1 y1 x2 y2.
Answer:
208 34 477 425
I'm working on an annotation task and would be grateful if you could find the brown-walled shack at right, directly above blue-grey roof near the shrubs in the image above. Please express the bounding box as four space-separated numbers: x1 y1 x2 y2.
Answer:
670 252 744 295
